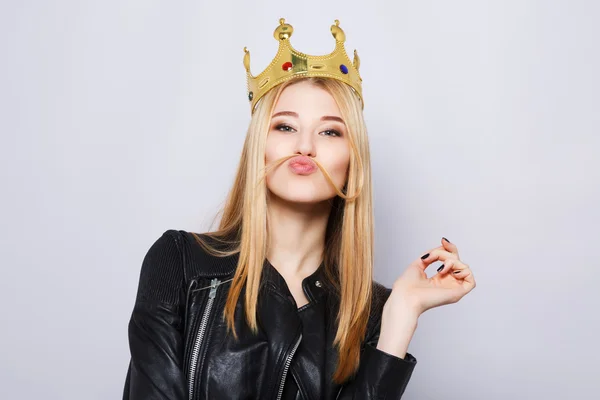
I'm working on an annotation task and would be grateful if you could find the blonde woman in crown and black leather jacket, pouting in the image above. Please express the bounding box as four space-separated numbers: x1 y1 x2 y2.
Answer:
124 20 475 400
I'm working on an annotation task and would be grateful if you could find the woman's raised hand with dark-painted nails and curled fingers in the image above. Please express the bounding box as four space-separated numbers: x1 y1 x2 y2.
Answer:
386 238 475 316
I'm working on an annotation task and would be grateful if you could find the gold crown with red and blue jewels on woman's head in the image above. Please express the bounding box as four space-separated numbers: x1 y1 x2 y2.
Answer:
244 18 365 114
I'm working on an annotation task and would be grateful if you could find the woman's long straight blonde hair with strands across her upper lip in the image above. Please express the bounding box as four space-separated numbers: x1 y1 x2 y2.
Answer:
195 77 374 384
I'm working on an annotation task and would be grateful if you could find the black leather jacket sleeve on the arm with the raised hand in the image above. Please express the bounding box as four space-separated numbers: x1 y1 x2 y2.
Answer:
337 286 417 400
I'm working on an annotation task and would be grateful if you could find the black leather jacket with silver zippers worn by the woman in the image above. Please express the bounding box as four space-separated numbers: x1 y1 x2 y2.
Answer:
123 230 416 400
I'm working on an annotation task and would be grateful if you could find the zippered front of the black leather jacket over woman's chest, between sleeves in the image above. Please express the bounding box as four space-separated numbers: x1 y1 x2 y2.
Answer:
184 279 335 400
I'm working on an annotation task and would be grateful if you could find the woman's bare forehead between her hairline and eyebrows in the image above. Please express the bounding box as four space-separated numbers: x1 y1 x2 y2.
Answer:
274 82 340 116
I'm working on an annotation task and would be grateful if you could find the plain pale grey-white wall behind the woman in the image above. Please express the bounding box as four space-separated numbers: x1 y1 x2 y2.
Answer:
0 0 600 400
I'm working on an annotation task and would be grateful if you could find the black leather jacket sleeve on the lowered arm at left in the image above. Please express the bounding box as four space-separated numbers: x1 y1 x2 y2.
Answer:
123 230 187 400
